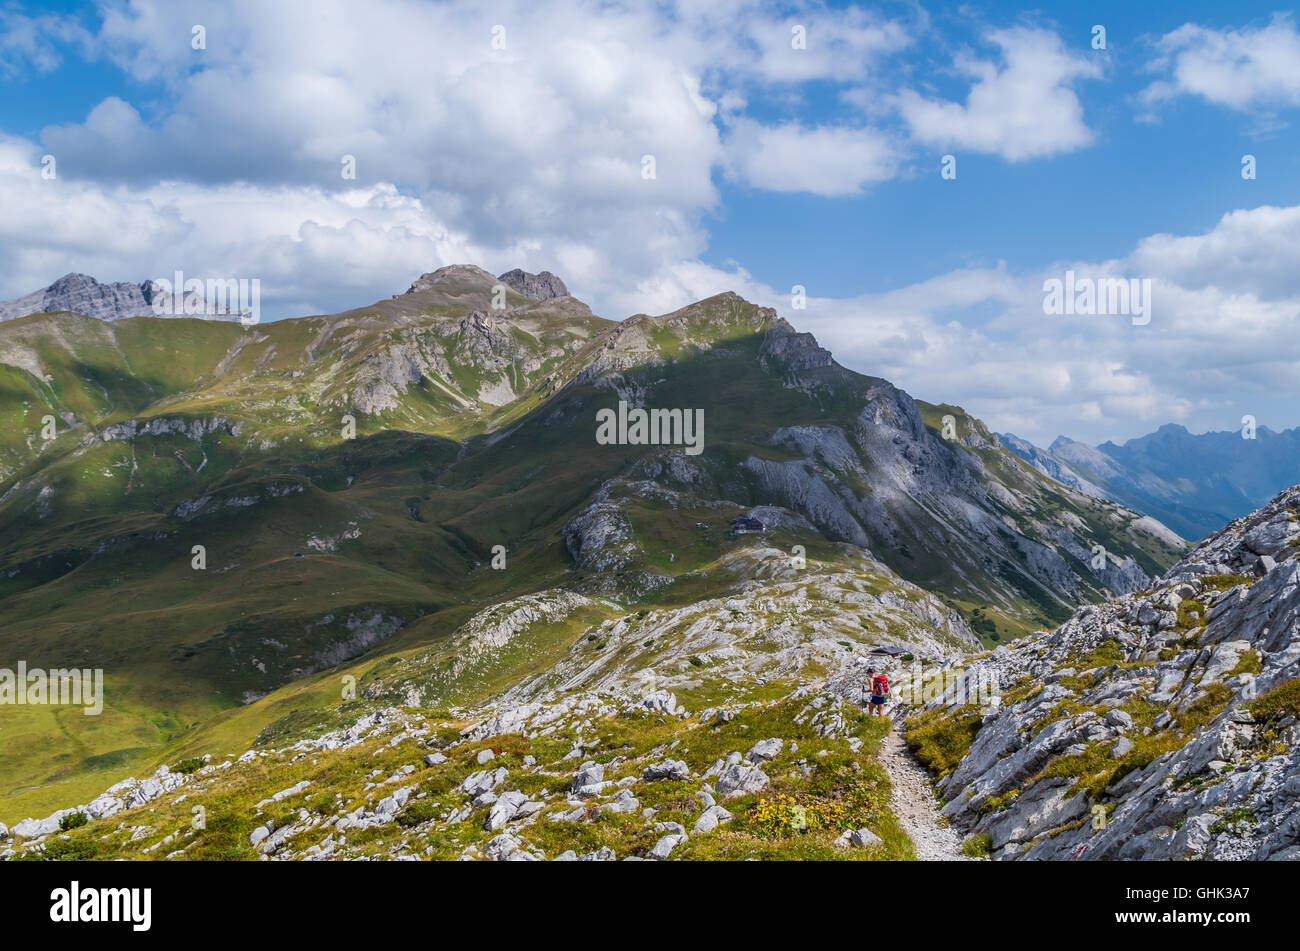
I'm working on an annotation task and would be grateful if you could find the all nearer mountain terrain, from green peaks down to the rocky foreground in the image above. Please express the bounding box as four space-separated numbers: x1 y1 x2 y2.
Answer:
0 265 1300 861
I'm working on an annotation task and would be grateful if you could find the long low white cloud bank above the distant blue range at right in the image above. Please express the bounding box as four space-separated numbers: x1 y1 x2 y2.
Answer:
657 207 1300 444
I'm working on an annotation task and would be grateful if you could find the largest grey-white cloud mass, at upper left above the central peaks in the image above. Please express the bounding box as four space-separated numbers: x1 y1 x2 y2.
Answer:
17 0 911 315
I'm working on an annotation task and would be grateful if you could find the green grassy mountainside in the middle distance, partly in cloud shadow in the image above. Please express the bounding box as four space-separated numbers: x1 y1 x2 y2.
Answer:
0 274 1173 817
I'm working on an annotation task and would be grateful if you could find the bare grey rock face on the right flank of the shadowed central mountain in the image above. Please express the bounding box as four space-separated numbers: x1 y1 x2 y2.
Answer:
741 379 1159 604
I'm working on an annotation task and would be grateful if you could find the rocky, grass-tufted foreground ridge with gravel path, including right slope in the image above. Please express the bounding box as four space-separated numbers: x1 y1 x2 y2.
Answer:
0 423 1300 861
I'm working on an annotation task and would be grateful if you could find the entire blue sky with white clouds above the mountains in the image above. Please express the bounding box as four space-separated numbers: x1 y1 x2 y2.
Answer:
0 0 1300 444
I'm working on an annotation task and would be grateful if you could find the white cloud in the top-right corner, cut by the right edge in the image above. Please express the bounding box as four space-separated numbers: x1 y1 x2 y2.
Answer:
1141 14 1300 110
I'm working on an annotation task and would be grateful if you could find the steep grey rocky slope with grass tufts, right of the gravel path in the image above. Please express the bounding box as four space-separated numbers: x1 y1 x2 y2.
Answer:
909 486 1300 860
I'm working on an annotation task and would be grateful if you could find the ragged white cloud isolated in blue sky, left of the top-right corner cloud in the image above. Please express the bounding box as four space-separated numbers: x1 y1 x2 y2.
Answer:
897 27 1101 161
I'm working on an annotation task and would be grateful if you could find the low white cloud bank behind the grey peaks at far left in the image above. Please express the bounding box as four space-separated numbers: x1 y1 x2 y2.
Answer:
0 139 488 317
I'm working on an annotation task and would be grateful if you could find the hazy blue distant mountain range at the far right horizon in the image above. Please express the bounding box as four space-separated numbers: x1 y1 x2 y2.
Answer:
998 424 1300 540
